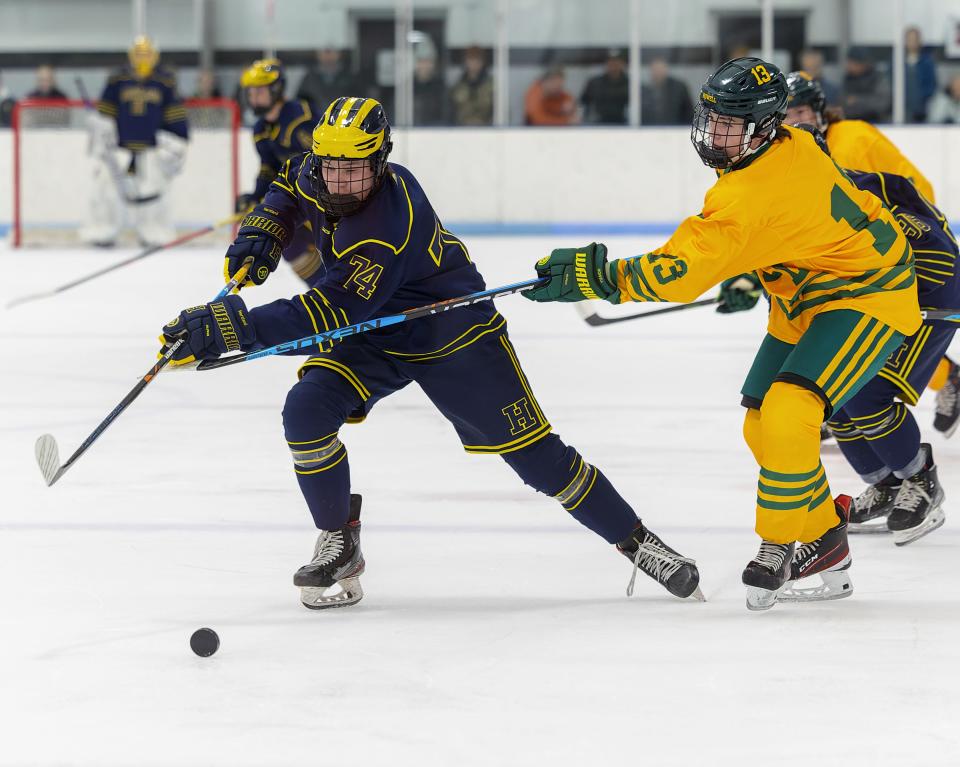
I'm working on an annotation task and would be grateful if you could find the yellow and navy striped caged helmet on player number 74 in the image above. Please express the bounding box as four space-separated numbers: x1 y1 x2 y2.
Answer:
309 96 393 217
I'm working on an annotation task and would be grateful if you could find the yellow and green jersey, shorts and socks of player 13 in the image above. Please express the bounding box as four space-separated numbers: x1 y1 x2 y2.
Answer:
610 128 920 544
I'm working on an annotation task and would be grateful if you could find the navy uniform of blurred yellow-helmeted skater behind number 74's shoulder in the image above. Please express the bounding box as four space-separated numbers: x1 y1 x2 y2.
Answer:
251 99 320 284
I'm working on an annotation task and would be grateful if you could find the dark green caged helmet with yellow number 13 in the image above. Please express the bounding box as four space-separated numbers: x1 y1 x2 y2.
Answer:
690 57 787 170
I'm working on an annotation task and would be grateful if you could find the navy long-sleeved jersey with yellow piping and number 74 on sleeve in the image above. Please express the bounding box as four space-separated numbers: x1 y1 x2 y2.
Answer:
239 155 498 362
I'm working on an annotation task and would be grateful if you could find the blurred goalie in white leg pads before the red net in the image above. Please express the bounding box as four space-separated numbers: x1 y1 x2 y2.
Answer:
80 36 187 247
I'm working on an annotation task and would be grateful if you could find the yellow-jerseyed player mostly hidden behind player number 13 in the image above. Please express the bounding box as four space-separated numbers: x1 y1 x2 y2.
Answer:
786 71 960 436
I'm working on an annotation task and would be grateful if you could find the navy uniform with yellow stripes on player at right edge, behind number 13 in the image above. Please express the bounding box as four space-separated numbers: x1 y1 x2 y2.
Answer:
828 171 960 485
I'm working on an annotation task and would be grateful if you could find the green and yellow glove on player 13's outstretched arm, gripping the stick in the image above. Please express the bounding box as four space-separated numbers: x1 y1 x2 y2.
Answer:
522 242 620 304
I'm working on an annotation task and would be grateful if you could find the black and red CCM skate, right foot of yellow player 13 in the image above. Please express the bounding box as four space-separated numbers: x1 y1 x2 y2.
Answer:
779 495 853 602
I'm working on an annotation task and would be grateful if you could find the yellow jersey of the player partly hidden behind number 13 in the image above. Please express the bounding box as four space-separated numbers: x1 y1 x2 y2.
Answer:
824 120 936 203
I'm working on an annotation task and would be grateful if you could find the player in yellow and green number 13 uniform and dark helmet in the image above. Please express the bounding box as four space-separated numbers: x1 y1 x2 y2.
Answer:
525 58 920 610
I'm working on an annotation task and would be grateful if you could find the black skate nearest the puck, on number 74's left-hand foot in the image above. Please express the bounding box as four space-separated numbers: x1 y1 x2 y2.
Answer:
293 495 365 610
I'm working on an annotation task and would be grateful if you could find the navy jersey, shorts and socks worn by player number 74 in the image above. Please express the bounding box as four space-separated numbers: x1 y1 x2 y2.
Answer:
240 154 638 543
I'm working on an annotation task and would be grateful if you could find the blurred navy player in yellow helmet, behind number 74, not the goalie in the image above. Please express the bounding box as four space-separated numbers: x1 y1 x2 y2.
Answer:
237 59 320 285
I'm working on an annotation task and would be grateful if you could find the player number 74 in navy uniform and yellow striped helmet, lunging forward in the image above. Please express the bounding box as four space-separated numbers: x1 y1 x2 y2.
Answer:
163 97 701 609
